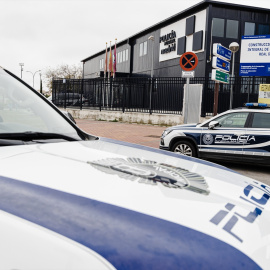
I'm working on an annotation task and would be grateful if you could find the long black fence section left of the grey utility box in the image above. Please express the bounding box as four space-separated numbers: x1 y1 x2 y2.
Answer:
52 78 190 114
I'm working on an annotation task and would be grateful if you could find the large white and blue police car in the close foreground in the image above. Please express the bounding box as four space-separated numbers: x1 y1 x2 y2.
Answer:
0 66 270 270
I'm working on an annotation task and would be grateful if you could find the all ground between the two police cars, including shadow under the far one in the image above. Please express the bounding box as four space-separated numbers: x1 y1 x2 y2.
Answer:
76 119 270 186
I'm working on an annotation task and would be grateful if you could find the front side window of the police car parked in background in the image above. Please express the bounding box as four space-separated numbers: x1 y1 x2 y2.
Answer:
215 112 249 128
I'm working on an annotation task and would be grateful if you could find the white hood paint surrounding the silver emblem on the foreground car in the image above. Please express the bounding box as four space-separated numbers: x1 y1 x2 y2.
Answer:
0 138 270 269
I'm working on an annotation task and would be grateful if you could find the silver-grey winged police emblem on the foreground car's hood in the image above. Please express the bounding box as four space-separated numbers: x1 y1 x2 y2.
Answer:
88 158 209 195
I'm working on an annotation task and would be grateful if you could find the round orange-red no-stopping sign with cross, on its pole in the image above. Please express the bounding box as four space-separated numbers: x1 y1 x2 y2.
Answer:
180 52 198 124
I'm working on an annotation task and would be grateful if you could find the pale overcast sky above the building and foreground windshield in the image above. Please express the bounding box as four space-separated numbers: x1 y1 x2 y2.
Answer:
0 0 270 88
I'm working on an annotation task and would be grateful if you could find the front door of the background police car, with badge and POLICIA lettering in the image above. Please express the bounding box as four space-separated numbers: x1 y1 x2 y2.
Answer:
199 111 249 159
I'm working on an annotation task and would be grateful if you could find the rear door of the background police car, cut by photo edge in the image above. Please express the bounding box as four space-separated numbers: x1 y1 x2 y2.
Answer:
243 112 270 162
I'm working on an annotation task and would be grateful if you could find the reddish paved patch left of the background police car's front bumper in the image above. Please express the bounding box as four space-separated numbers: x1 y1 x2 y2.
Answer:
76 119 166 148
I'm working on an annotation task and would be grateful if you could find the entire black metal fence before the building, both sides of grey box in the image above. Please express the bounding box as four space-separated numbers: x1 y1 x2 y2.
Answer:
52 77 270 116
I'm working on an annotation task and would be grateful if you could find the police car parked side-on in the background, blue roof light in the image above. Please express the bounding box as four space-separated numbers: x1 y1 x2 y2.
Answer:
160 103 270 165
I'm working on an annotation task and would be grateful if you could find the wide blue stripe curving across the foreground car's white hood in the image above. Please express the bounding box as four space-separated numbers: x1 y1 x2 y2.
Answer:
0 177 260 270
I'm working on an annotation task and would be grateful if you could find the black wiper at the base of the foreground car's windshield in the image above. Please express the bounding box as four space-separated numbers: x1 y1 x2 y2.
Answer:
0 131 78 142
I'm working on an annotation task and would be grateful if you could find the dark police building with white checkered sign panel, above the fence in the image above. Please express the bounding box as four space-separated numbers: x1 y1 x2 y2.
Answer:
82 0 270 79
